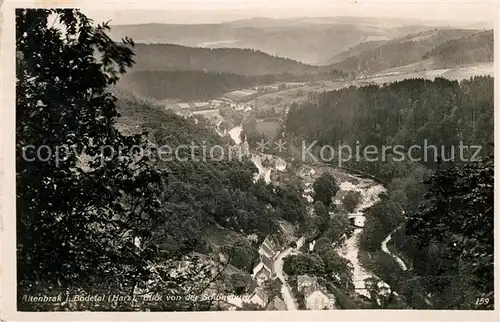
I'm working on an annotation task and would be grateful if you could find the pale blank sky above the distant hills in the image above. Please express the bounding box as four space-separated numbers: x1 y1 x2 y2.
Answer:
82 0 498 26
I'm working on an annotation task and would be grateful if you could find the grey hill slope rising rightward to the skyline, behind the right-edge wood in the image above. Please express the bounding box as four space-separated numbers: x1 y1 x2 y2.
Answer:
329 29 484 74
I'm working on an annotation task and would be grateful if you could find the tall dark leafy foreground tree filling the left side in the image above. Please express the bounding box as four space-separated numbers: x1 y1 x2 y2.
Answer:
16 9 173 300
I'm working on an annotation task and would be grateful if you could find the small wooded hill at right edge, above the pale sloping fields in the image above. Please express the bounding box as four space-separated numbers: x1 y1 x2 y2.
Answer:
424 30 494 66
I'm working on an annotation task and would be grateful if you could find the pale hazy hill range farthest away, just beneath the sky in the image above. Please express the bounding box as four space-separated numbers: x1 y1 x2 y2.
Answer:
110 17 429 64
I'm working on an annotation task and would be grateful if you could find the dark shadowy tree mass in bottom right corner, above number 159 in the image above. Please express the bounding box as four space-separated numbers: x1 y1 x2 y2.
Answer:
406 158 494 309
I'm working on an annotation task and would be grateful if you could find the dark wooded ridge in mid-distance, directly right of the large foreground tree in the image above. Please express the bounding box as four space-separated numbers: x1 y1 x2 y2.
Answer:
129 44 318 75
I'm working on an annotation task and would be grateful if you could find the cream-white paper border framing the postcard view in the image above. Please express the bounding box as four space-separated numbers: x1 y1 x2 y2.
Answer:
0 0 500 321
